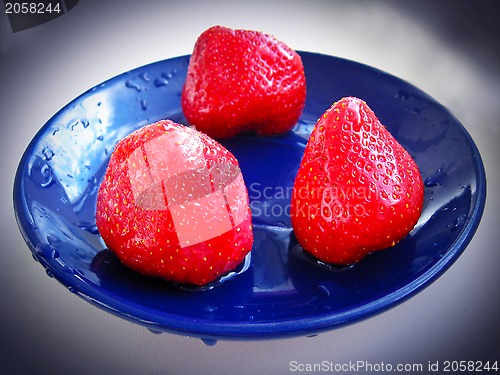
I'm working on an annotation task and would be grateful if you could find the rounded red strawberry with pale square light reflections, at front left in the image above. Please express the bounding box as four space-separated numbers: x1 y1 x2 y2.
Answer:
96 120 253 285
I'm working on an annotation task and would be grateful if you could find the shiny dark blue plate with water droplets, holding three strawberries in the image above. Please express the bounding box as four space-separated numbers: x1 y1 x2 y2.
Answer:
14 52 486 339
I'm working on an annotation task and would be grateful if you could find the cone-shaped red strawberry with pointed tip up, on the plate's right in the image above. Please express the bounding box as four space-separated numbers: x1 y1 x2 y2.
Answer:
291 97 424 265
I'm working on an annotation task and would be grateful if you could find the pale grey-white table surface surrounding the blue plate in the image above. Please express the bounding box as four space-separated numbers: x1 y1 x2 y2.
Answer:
0 0 500 375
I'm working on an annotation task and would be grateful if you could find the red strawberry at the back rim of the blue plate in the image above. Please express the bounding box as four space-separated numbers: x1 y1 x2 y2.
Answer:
182 26 306 138
